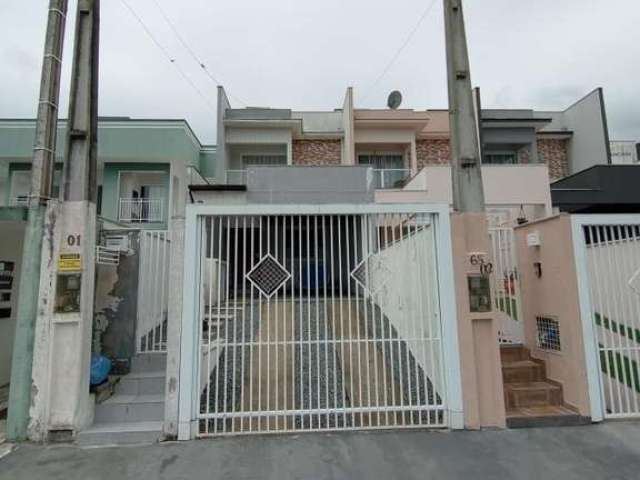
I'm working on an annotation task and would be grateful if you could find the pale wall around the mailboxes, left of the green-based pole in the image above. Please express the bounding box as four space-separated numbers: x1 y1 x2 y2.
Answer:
0 221 26 386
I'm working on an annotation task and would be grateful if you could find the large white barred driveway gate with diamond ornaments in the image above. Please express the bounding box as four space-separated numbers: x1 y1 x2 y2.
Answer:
181 207 461 436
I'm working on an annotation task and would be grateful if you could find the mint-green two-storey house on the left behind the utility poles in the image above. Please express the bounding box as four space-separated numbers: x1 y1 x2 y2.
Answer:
0 117 215 400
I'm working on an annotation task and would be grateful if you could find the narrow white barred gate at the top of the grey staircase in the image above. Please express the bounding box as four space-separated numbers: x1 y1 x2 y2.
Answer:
136 230 171 353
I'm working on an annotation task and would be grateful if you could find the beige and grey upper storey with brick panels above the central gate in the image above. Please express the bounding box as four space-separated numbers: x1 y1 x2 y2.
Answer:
204 87 610 227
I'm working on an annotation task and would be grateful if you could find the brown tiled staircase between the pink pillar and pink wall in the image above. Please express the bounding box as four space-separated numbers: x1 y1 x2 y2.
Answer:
500 345 589 428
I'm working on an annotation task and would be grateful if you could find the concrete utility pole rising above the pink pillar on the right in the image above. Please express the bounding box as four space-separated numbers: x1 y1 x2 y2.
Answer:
444 0 484 212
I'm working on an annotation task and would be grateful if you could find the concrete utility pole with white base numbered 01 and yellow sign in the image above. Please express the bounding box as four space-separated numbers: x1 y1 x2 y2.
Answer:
36 0 100 437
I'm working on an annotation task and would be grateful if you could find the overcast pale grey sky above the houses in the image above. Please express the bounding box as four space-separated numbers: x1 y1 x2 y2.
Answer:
0 0 640 143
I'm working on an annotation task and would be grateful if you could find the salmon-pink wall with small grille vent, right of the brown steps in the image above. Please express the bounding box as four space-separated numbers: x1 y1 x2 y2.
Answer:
516 215 590 416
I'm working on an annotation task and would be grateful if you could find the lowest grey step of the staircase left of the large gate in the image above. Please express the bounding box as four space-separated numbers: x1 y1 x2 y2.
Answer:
77 422 162 446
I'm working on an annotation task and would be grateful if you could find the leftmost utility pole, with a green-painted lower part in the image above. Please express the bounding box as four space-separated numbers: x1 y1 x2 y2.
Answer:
7 0 67 441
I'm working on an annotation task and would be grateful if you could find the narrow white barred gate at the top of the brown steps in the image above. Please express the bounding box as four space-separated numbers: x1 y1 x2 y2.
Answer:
489 227 524 343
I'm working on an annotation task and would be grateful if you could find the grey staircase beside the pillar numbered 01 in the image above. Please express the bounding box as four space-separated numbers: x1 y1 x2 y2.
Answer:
78 353 167 446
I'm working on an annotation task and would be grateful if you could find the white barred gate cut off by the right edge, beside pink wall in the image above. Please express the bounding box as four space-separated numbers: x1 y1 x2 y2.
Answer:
572 215 640 418
